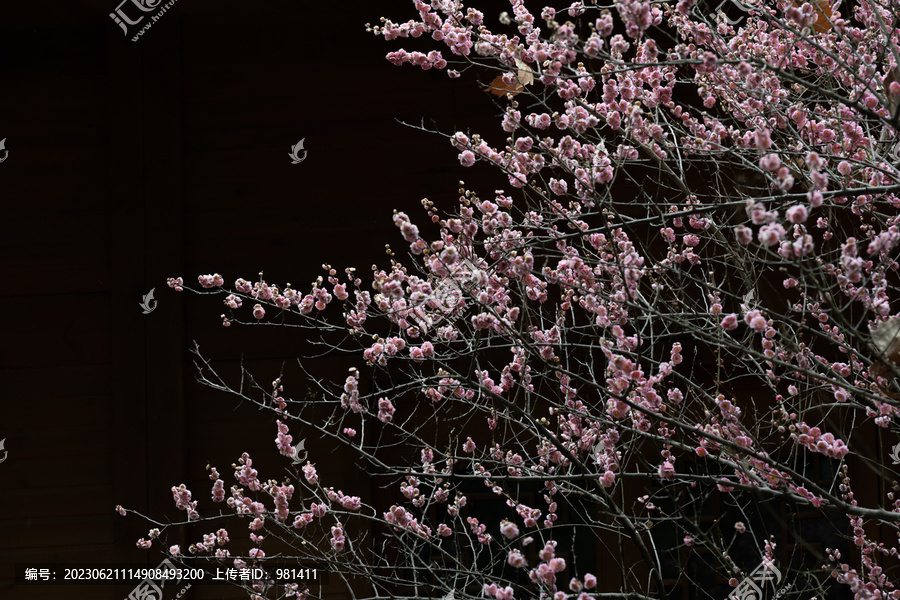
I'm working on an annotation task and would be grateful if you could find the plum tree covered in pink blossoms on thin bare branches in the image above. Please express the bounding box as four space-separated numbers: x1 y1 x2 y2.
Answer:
128 0 900 600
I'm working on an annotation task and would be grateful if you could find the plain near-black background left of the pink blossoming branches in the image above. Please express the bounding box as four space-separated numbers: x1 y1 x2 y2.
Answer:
0 0 500 600
